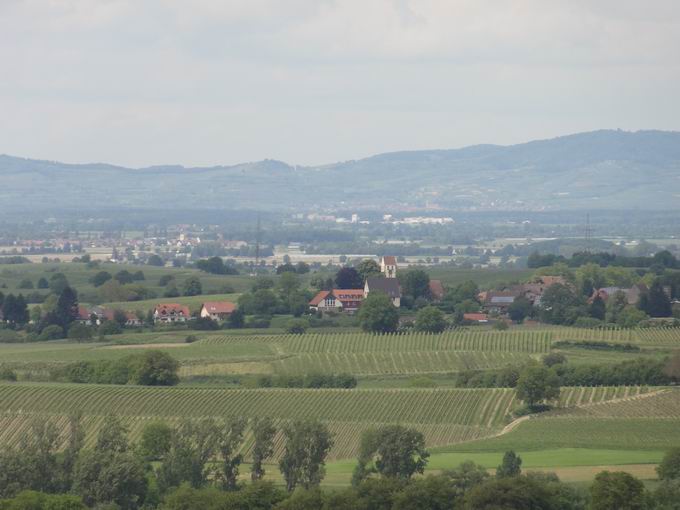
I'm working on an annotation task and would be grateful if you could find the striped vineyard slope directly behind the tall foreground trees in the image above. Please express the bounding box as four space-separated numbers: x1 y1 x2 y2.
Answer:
0 384 653 459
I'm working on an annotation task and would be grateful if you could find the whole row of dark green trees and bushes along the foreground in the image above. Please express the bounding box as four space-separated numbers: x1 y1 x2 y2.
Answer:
5 416 680 510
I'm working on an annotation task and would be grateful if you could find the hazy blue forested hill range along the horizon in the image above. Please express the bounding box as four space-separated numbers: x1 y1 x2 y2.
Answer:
0 130 680 214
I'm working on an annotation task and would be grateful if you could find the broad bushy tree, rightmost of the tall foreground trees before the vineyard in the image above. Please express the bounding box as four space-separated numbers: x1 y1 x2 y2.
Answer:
352 425 430 484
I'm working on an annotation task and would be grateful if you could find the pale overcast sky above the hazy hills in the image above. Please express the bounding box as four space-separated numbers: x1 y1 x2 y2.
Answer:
0 0 680 167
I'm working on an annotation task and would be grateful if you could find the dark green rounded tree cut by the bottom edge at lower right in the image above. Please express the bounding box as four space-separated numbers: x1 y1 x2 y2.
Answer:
590 471 646 510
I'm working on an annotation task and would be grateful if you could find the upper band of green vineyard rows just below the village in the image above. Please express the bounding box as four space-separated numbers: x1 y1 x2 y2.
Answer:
5 328 680 376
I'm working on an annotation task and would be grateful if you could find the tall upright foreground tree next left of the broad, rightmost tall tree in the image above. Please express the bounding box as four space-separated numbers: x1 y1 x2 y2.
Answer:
279 421 333 492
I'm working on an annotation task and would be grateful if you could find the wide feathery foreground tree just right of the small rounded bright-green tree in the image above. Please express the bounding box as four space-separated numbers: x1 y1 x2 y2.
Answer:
158 419 217 491
